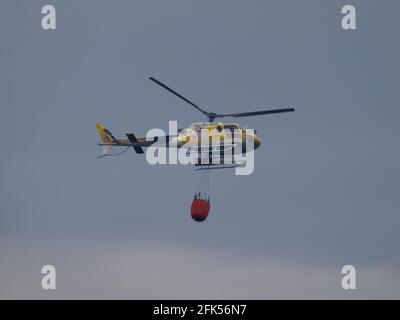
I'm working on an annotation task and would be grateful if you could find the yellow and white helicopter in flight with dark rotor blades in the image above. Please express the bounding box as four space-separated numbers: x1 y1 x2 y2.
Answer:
96 77 295 170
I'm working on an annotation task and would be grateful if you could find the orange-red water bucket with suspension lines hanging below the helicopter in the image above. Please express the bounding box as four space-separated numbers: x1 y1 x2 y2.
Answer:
190 171 211 222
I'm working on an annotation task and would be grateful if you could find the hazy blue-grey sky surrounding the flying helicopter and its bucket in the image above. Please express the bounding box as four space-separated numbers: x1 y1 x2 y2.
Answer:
0 0 400 298
